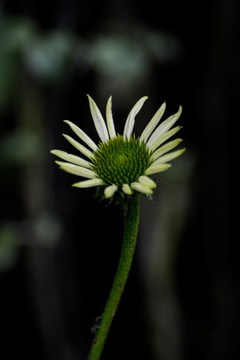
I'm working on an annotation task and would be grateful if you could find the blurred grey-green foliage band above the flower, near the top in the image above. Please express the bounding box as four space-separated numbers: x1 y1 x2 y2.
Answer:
0 15 181 112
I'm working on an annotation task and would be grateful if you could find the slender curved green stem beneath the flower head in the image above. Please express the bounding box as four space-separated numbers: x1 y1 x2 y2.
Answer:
88 194 139 360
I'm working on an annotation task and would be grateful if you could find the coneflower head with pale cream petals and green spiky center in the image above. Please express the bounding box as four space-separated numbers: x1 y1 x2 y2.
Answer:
51 95 185 198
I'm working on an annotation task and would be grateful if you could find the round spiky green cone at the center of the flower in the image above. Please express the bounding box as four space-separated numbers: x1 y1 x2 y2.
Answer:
92 135 151 186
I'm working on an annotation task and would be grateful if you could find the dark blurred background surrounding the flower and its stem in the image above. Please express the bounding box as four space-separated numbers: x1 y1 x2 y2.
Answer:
0 0 237 360
